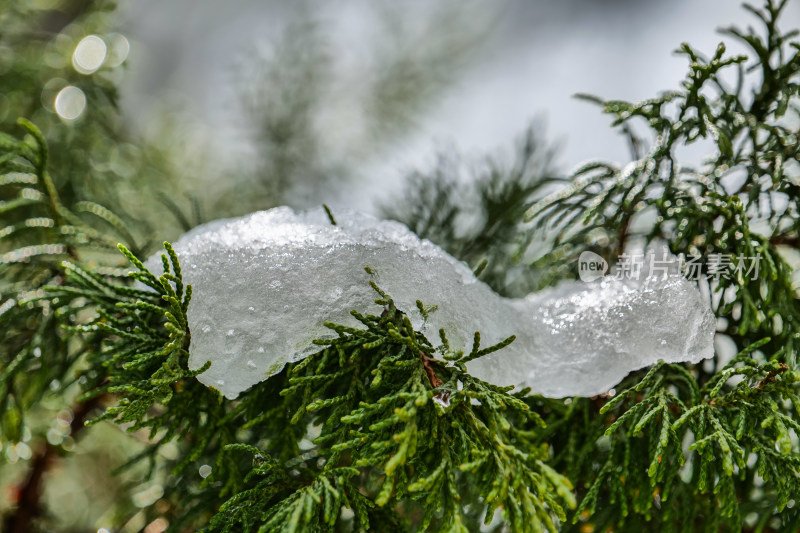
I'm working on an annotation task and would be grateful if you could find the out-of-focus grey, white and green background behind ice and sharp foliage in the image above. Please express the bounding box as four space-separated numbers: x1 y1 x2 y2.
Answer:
0 0 800 533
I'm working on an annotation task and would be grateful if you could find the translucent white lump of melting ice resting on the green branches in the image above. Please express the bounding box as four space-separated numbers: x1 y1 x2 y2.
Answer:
148 207 714 398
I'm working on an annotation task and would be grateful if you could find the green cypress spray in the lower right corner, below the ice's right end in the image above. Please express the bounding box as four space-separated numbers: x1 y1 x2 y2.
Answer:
564 353 800 531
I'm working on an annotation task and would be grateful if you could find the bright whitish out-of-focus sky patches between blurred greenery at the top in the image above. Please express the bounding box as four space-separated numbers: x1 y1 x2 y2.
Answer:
114 0 800 211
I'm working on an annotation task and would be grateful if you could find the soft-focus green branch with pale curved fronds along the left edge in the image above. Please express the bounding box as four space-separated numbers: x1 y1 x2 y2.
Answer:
0 120 124 441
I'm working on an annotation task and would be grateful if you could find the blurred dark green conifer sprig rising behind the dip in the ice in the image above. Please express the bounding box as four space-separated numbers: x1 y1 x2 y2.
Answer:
382 124 560 296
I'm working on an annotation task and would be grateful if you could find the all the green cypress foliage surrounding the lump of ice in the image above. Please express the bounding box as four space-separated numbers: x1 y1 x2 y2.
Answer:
0 0 800 532
